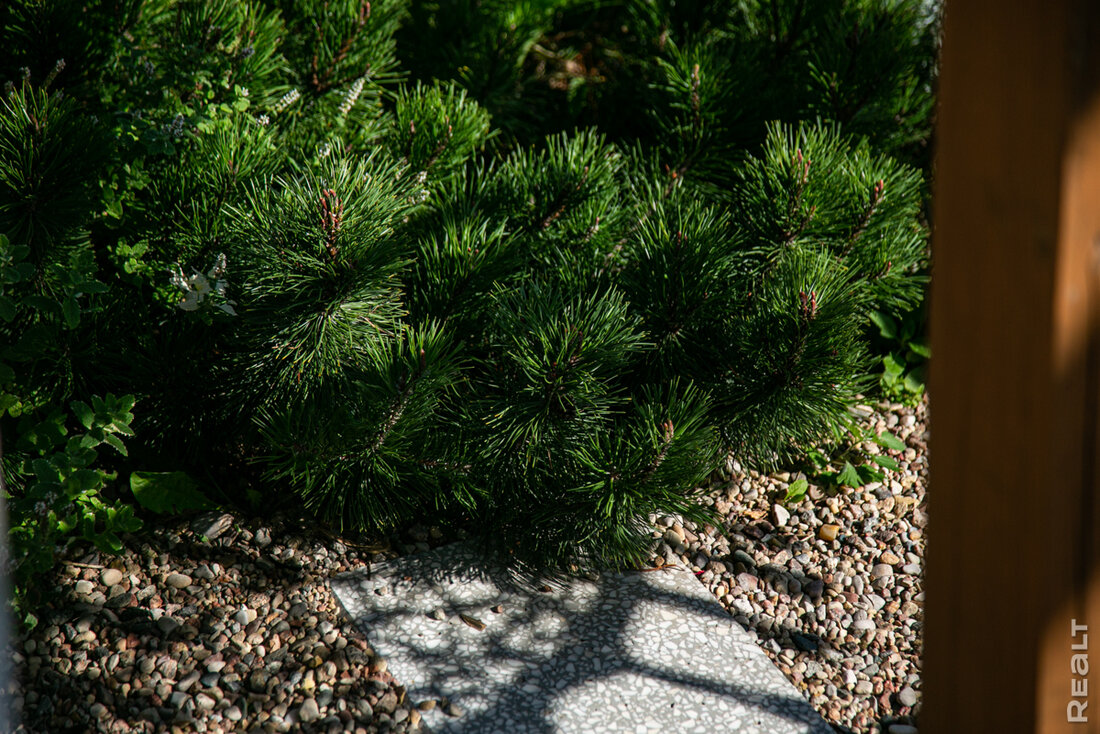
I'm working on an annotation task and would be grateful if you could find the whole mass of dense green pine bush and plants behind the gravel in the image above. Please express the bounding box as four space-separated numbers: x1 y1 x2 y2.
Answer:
0 0 937 607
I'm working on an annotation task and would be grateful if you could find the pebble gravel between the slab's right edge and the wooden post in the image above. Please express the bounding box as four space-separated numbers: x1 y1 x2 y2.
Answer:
651 401 928 734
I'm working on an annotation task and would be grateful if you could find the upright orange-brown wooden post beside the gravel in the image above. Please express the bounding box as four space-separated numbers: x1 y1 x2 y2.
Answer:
919 0 1100 734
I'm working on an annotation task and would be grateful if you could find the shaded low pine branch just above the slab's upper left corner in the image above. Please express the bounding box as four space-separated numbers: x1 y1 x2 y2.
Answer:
257 327 470 529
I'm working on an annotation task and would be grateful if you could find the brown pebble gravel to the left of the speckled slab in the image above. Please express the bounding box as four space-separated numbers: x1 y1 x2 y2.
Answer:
7 513 446 734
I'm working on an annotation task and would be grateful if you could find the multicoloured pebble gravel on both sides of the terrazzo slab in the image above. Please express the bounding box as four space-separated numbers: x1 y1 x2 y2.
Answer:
12 403 927 734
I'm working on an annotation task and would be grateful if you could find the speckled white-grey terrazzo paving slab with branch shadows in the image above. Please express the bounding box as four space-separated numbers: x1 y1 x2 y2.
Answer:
331 544 833 734
